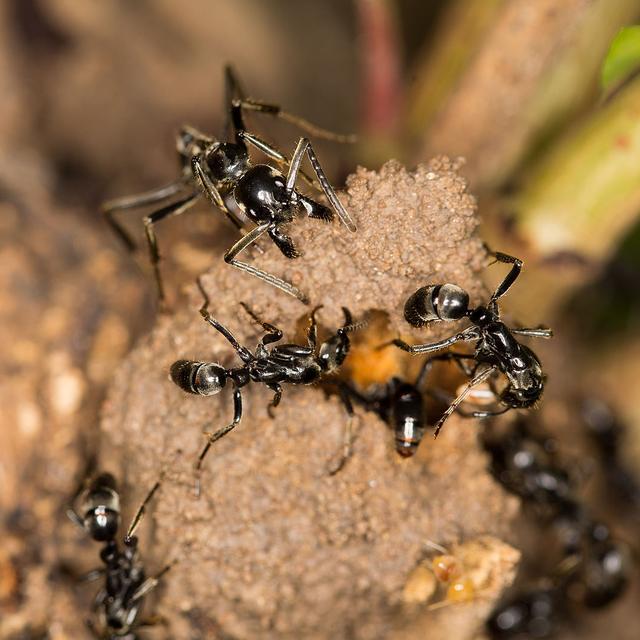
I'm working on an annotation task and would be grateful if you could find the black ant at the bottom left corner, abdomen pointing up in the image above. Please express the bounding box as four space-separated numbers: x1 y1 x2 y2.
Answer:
67 473 172 640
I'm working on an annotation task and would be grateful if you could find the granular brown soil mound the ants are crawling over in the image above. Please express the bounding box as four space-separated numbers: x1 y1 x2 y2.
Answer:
102 159 516 638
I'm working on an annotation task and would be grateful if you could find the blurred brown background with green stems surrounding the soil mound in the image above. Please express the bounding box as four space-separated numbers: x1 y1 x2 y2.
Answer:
0 0 640 639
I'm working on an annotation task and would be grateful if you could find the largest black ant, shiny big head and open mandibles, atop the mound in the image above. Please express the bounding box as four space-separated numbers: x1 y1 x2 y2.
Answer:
103 67 356 304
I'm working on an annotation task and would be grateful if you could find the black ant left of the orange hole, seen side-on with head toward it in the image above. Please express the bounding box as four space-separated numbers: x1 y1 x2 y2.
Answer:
170 280 364 495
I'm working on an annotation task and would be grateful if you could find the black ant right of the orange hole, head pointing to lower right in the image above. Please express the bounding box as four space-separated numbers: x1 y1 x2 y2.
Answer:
383 252 553 437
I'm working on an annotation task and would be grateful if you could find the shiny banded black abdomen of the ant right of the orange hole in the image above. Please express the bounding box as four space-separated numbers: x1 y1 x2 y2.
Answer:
404 284 469 327
